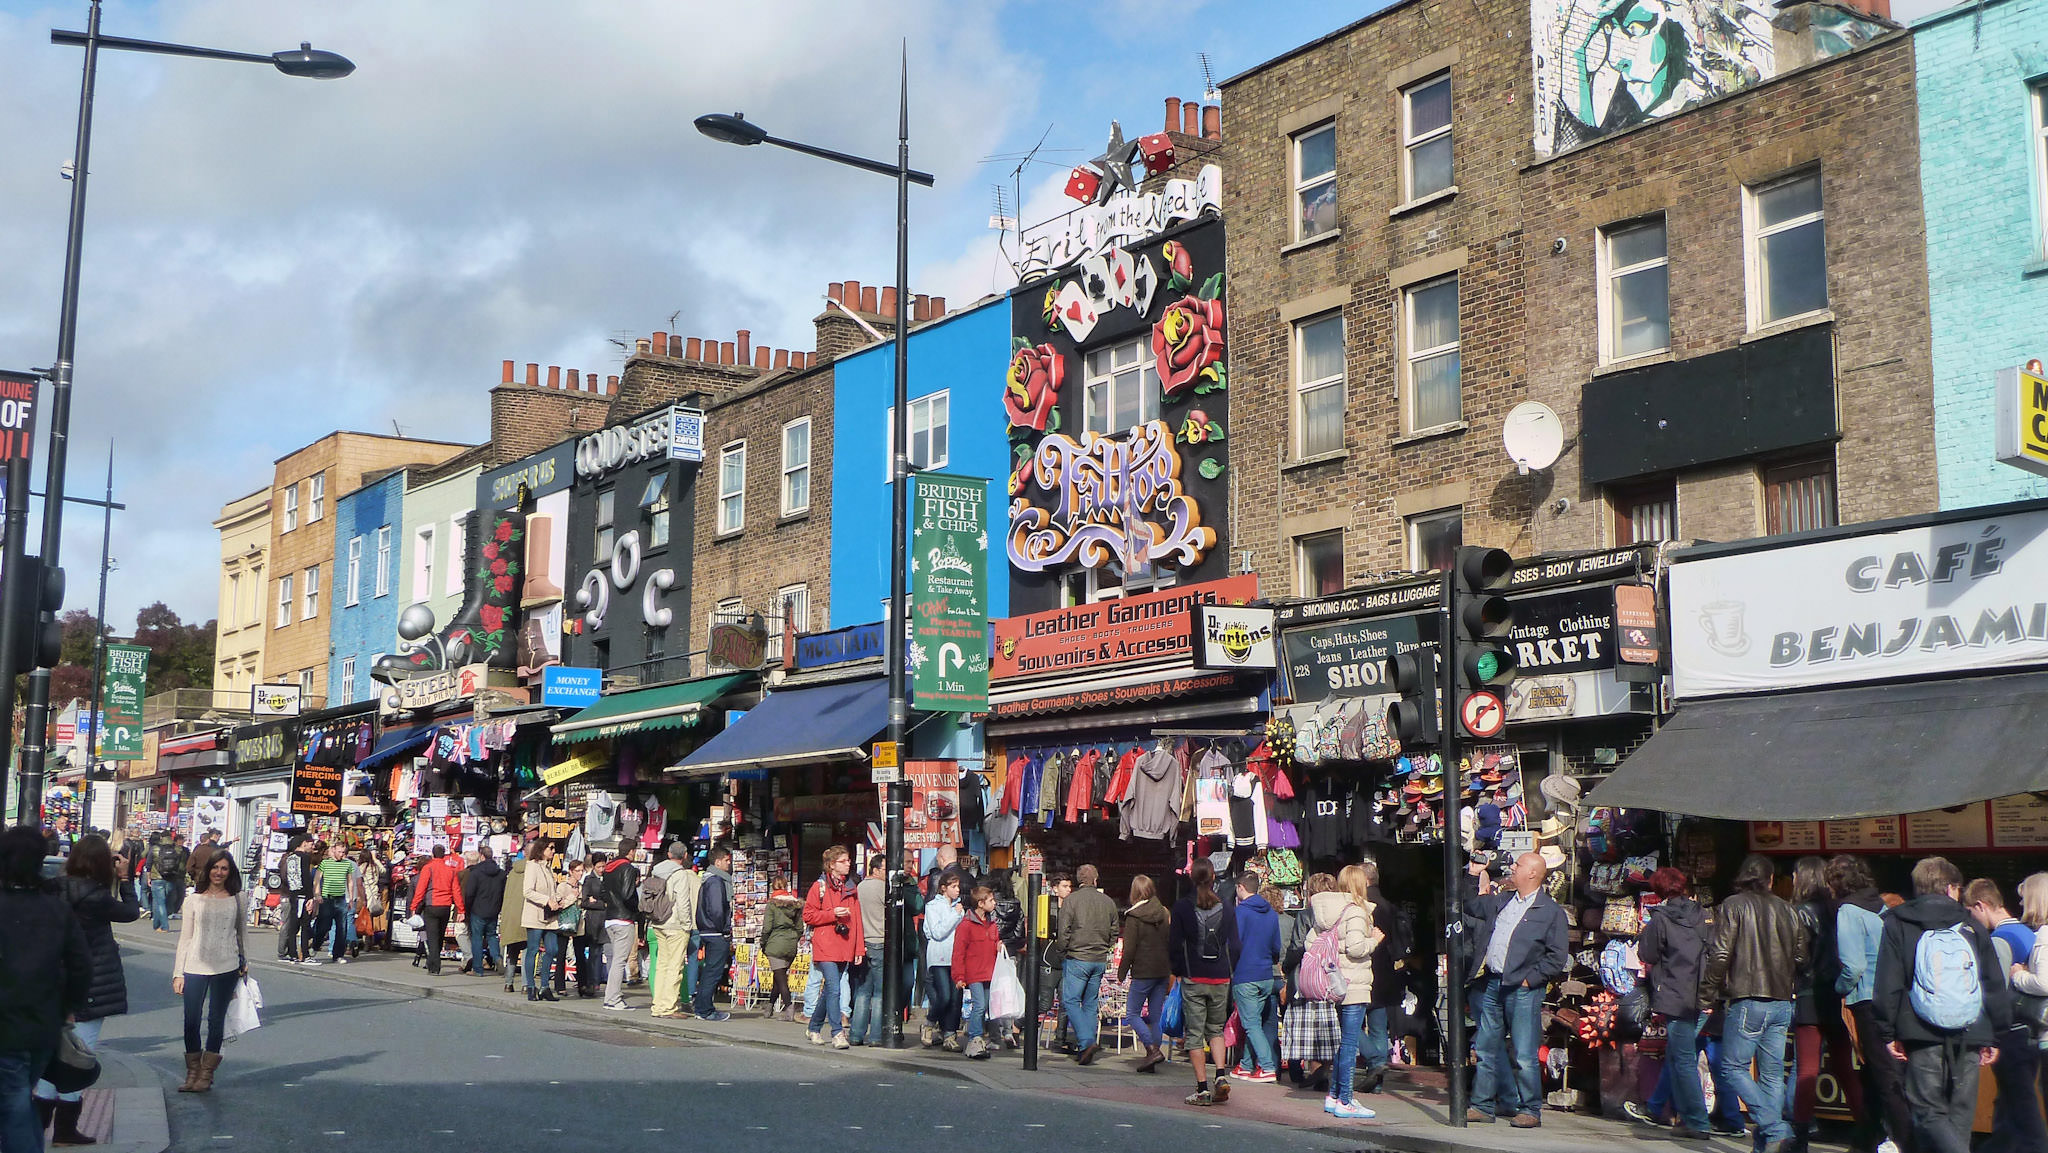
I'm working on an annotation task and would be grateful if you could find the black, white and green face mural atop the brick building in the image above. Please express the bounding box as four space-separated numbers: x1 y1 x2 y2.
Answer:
1530 0 1776 156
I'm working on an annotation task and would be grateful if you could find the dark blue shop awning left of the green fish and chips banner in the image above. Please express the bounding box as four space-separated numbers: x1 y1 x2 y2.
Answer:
668 678 889 778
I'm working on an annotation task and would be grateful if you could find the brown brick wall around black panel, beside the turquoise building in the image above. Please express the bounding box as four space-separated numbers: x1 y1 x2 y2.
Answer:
1524 35 1935 549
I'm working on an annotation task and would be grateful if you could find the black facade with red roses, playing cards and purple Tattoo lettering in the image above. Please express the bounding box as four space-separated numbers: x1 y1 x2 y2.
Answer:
1001 208 1229 612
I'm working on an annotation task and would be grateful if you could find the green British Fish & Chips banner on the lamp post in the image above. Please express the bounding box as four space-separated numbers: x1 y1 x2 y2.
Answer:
909 473 989 713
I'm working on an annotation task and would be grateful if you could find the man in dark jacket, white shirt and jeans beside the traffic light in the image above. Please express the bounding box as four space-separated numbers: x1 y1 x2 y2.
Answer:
1464 852 1571 1128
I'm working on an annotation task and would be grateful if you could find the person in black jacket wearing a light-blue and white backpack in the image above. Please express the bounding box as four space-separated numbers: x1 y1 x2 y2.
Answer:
1872 856 2013 1153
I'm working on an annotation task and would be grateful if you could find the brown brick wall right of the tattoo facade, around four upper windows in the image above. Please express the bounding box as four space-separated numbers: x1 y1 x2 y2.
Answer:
1219 2 1536 594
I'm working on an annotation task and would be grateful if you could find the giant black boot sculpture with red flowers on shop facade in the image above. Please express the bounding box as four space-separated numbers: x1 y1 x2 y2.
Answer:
371 508 526 684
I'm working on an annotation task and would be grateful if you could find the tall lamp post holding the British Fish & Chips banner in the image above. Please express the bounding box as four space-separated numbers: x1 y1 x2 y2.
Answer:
696 51 932 1049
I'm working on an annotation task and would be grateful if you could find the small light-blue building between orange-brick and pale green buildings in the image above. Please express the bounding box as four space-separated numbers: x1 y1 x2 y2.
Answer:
328 469 408 704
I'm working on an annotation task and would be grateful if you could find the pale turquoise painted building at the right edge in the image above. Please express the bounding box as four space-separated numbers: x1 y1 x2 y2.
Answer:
1913 0 2048 508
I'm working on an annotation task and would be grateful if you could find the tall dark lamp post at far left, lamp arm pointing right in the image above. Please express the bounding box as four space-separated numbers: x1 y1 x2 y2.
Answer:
0 0 356 823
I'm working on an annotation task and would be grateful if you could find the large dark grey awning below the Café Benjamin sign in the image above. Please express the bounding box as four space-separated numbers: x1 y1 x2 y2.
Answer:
1587 672 2048 821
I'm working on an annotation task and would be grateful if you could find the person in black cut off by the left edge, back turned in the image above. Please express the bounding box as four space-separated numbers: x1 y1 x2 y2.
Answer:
0 825 92 1149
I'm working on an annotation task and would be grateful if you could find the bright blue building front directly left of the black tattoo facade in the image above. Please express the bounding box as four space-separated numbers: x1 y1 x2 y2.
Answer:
831 297 1010 629
